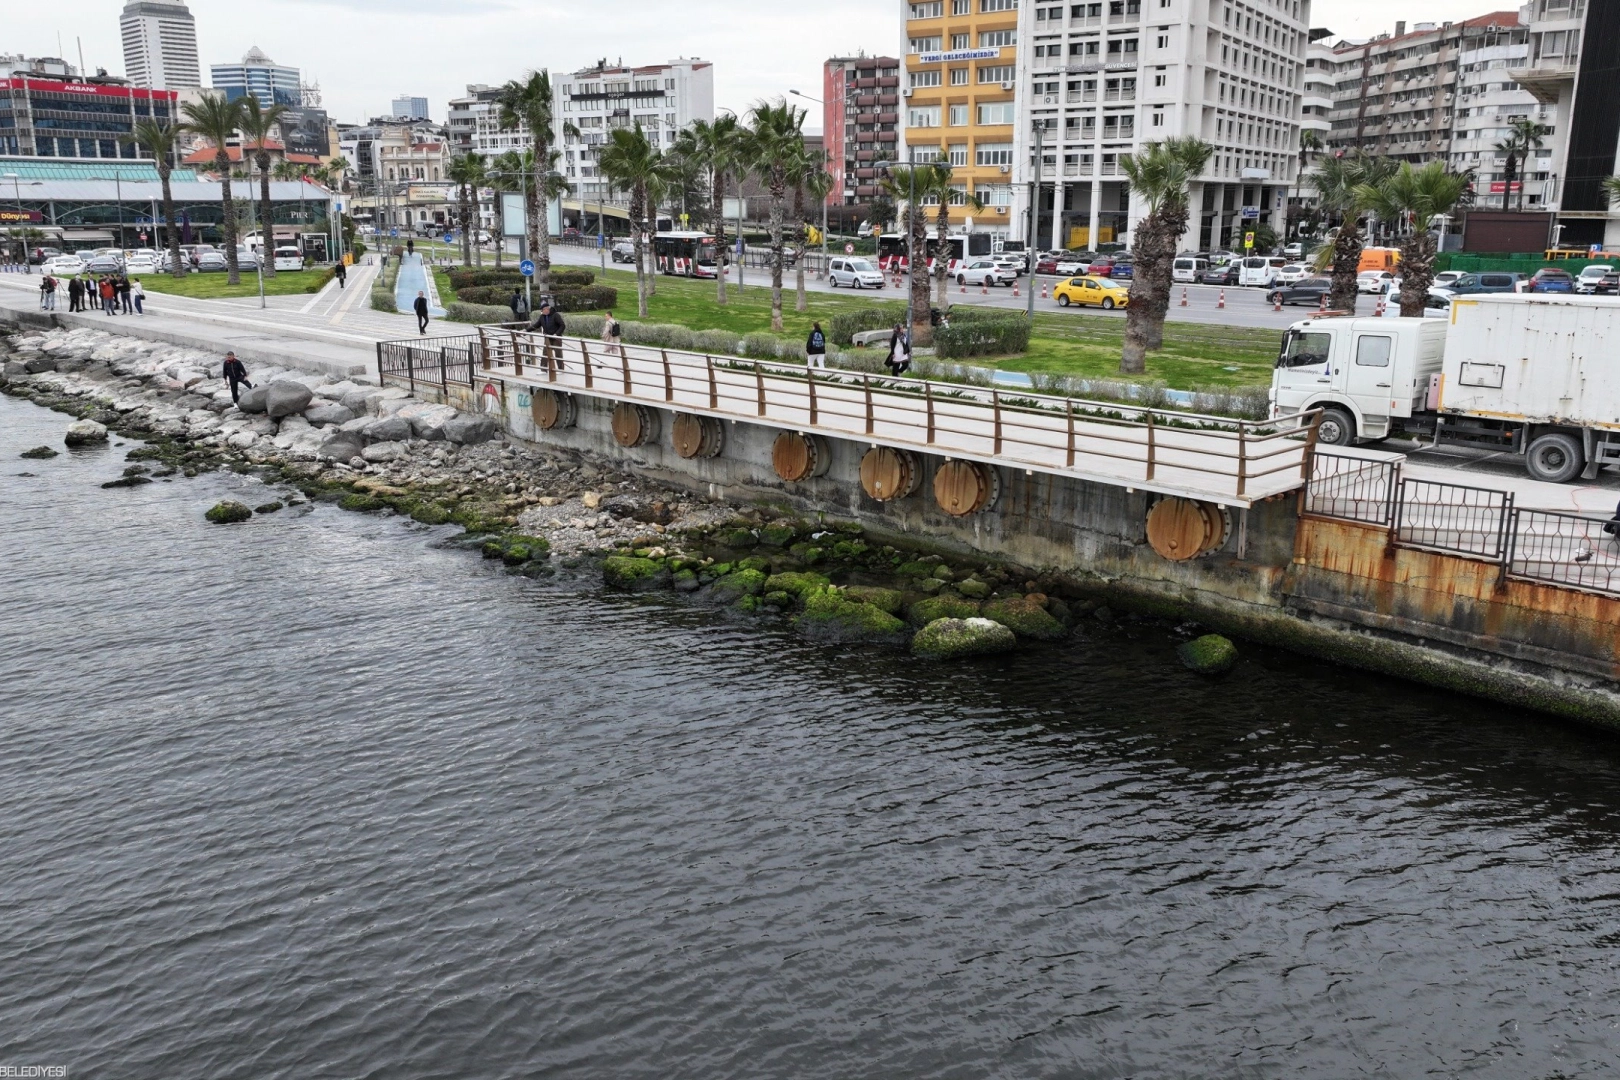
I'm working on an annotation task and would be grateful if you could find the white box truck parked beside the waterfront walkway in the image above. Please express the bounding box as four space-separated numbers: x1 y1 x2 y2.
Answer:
1272 293 1620 483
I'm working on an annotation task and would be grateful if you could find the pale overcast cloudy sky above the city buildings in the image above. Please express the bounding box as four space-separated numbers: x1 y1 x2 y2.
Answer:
9 0 1513 126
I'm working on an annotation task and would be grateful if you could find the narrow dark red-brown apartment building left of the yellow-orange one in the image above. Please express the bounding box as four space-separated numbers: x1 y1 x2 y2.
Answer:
821 57 901 206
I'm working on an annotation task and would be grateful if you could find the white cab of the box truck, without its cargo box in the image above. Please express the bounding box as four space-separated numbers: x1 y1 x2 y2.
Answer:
1272 316 1447 445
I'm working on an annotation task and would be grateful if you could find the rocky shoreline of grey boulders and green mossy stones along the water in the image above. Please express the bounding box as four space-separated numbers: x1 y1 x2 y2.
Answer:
0 320 1233 663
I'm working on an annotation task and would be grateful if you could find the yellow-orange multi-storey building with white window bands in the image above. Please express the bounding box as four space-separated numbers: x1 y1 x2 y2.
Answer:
894 0 1024 238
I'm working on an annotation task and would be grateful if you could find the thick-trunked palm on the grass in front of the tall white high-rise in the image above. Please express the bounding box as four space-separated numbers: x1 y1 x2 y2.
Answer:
1119 136 1215 374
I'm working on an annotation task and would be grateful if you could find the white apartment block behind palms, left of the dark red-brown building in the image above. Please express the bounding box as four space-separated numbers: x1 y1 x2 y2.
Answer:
552 57 714 206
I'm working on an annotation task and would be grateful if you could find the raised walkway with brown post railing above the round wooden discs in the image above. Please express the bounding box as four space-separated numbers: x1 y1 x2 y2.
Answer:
466 327 1317 505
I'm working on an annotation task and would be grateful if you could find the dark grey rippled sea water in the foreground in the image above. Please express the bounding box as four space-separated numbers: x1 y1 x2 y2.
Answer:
0 398 1620 1080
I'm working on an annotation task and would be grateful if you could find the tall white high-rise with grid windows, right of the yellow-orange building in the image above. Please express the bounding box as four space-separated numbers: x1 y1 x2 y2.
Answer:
1014 0 1311 249
